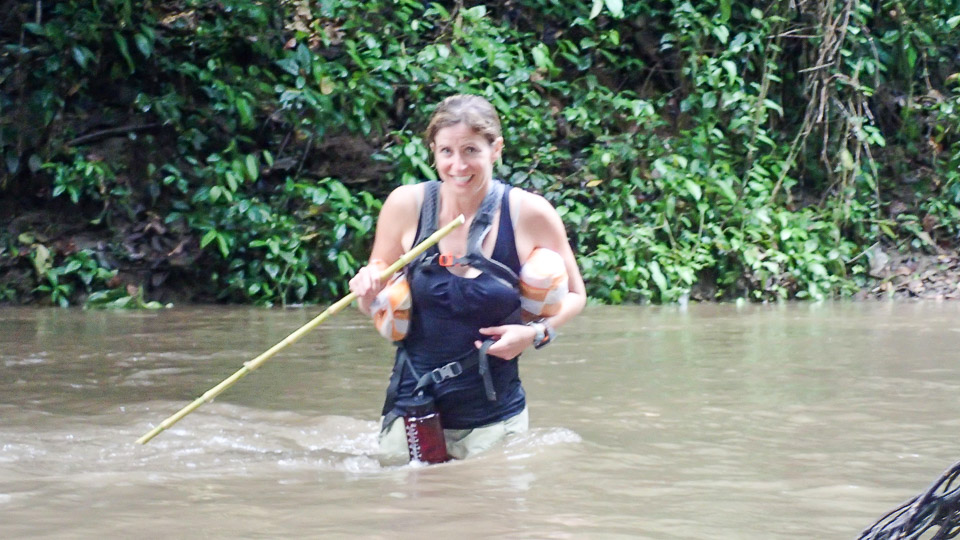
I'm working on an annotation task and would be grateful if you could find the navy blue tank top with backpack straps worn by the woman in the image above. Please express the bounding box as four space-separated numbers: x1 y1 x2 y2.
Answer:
383 181 526 432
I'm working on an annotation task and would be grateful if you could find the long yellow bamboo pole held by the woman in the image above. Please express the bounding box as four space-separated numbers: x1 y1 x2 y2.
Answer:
137 214 465 444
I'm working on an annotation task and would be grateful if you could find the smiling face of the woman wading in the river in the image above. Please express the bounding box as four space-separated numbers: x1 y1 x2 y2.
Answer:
430 122 503 196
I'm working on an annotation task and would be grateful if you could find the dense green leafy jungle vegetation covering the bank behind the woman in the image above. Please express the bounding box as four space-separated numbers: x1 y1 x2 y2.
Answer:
0 0 960 307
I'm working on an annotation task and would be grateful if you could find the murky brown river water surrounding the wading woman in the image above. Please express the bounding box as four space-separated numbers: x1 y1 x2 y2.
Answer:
0 302 960 540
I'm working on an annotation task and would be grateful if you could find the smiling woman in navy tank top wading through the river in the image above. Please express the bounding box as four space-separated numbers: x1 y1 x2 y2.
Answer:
350 95 586 460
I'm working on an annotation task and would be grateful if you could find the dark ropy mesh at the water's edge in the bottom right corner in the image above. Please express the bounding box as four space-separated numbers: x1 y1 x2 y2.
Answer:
858 462 960 540
